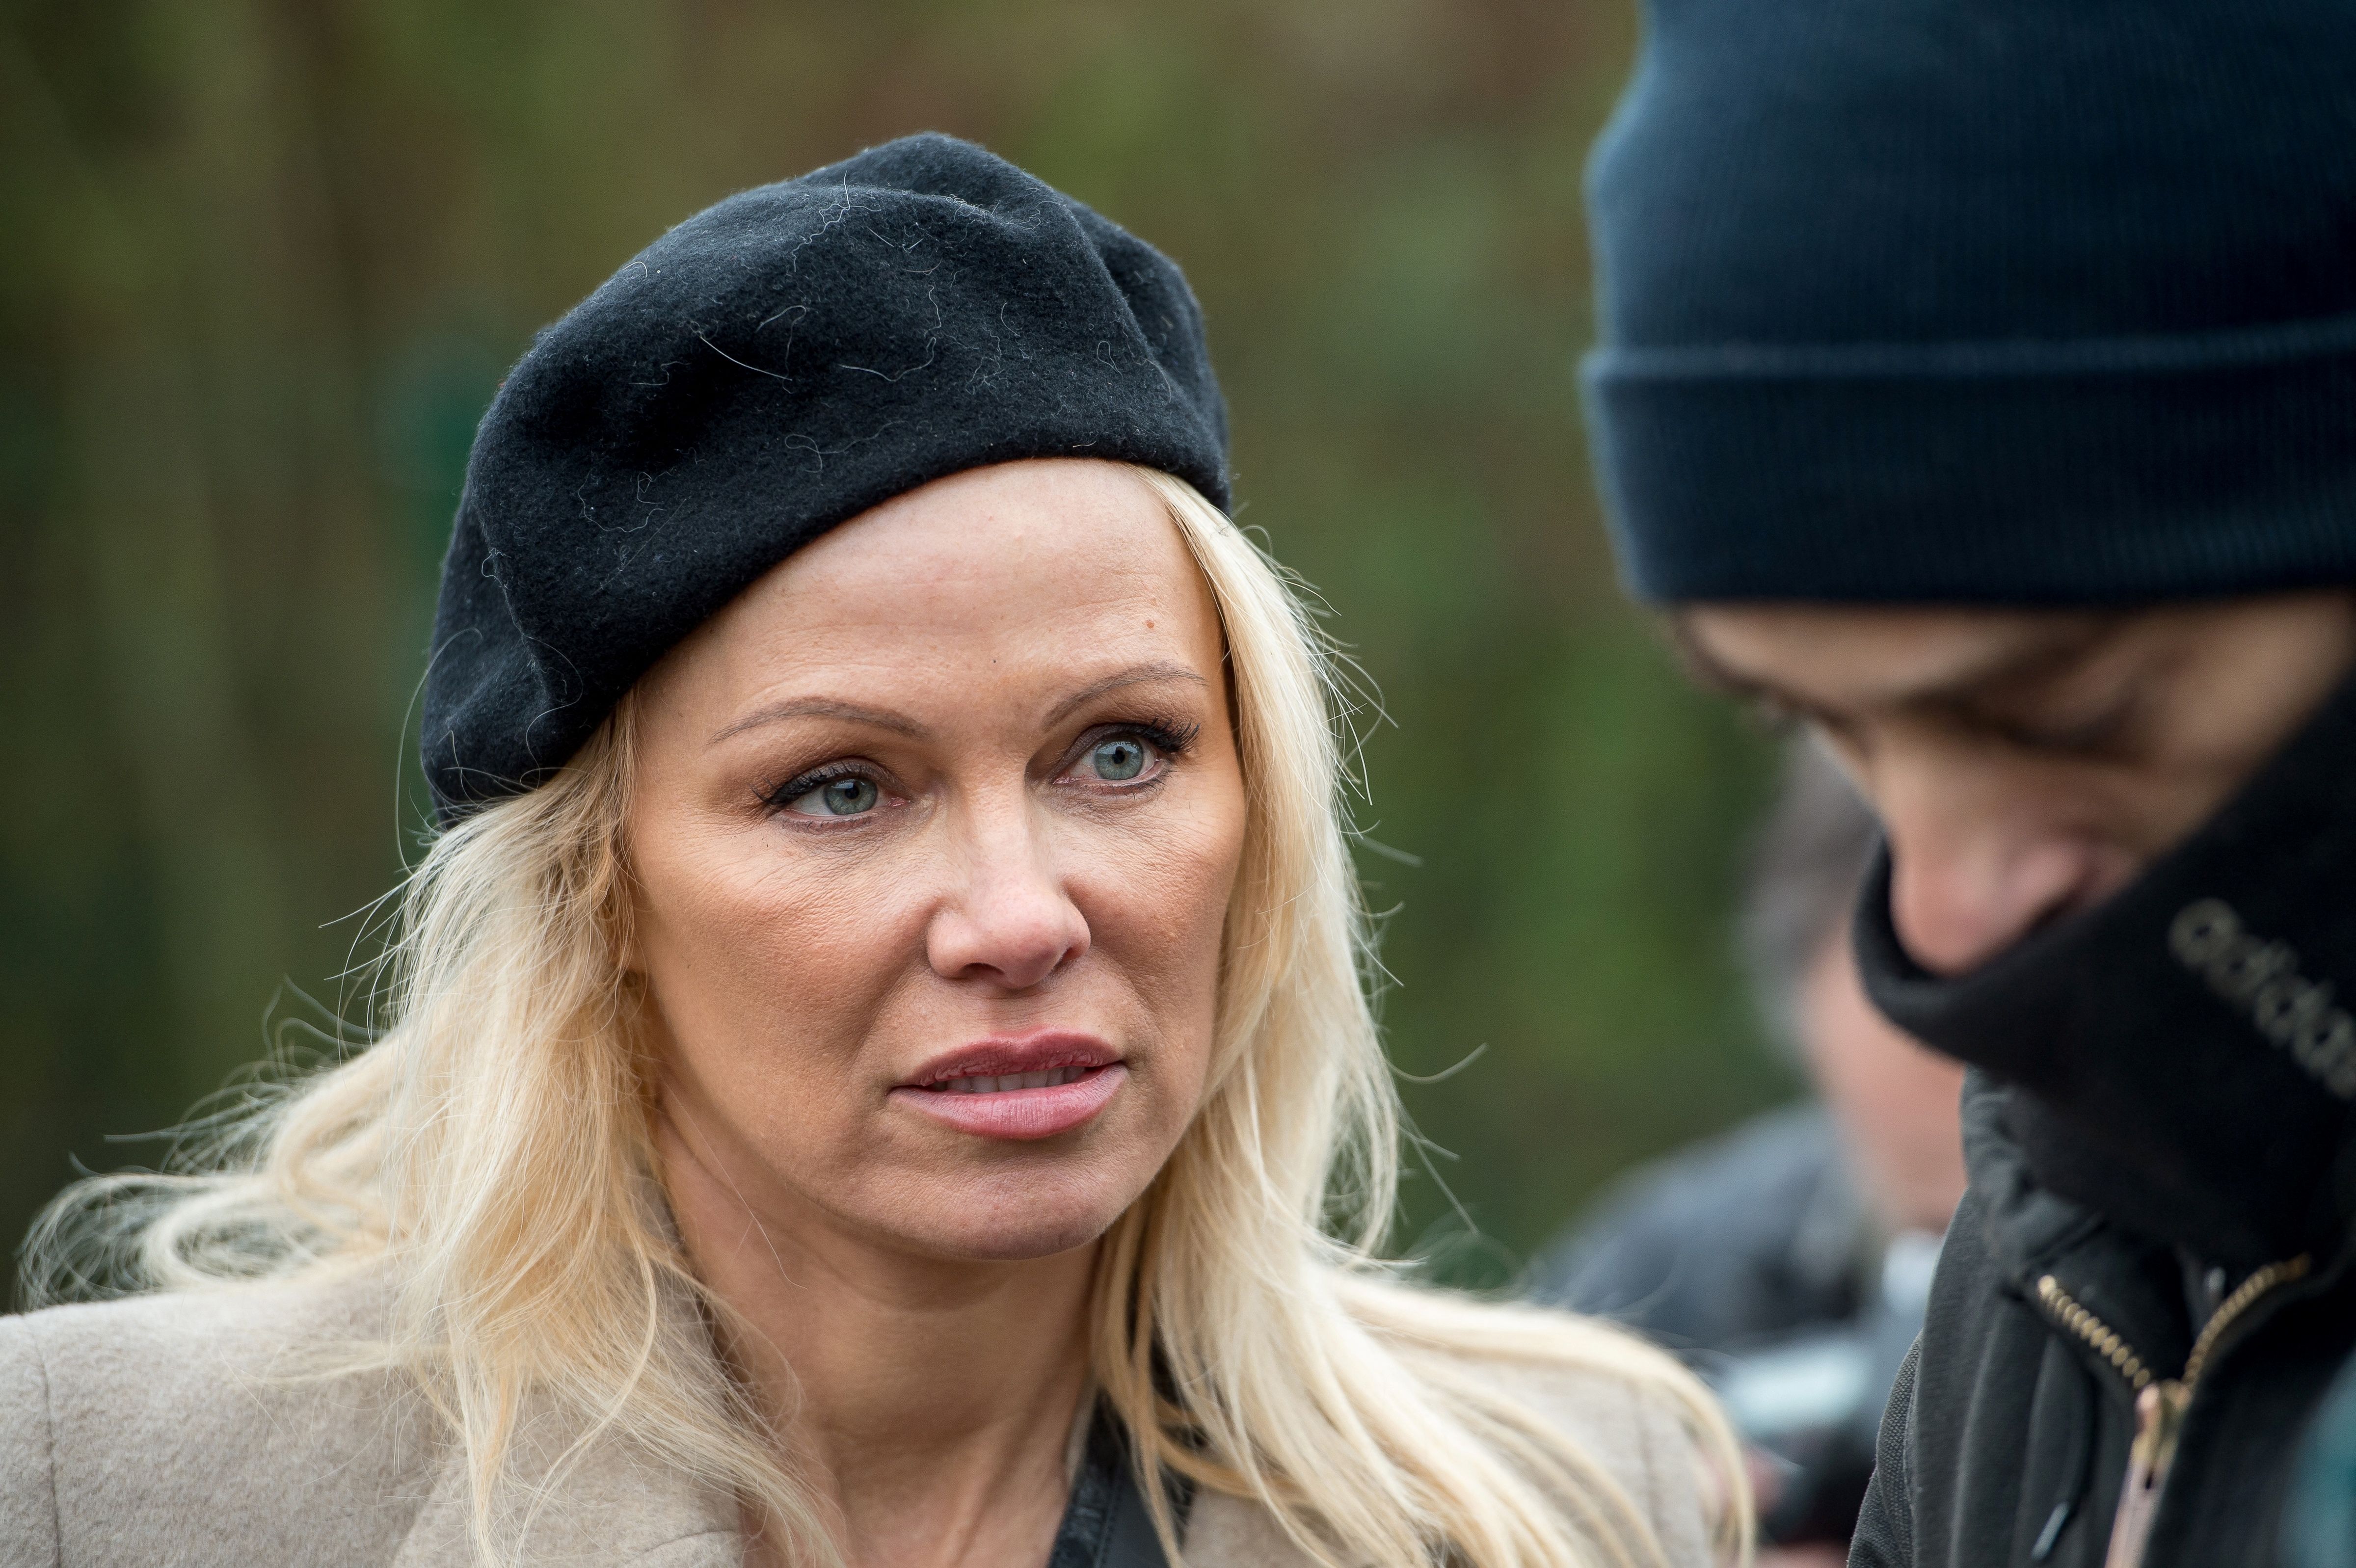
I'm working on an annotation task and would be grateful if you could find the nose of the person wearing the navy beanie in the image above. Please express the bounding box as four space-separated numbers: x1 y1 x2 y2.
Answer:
1873 763 2104 975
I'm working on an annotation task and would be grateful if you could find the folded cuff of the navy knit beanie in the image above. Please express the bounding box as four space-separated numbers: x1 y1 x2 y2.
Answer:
1581 318 2356 605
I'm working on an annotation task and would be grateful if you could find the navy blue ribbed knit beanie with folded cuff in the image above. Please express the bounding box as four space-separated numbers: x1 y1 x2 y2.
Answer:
1583 0 2356 603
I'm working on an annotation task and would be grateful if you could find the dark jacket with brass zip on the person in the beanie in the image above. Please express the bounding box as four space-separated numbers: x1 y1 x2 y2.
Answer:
1849 1074 2356 1568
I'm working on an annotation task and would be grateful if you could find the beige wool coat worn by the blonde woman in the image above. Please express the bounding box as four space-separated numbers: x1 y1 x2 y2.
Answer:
0 1281 1711 1568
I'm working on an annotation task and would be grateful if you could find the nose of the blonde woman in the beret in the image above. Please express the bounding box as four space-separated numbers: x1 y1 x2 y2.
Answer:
926 798 1089 991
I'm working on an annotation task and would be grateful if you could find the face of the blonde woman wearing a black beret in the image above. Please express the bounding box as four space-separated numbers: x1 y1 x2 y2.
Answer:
629 459 1244 1260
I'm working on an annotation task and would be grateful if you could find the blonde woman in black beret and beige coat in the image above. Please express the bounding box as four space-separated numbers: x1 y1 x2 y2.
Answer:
0 136 1741 1568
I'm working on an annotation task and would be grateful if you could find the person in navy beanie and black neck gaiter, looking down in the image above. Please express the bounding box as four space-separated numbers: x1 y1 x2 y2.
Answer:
1585 0 2356 1568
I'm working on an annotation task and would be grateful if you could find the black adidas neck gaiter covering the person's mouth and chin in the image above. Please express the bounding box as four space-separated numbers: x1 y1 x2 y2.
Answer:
1854 664 2356 1269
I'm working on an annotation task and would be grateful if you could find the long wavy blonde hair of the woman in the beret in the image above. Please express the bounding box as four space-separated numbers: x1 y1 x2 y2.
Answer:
26 469 1748 1568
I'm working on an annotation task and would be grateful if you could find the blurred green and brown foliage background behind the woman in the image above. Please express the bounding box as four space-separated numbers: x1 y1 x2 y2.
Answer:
0 0 1793 1283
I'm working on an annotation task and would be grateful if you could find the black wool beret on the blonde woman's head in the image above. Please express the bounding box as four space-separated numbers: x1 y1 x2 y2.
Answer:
419 134 1228 822
